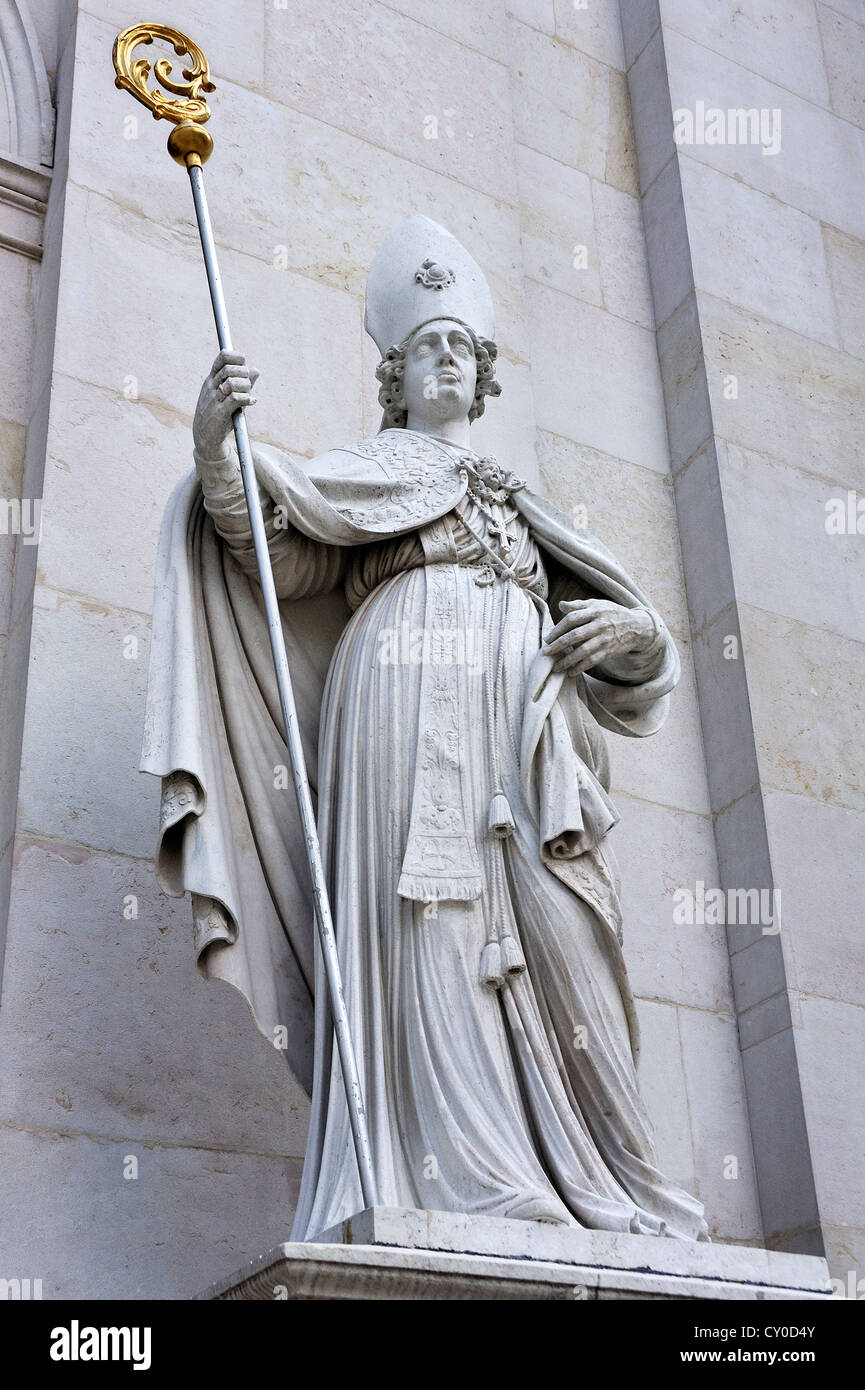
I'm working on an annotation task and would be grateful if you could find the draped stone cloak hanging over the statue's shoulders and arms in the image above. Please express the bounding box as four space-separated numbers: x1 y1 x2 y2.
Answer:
142 430 700 1234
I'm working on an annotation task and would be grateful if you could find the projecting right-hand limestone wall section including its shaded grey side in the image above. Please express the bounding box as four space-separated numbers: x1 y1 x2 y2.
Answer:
623 0 865 1280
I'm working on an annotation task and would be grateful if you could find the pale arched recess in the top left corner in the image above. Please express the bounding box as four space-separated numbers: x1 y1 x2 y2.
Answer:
0 0 54 168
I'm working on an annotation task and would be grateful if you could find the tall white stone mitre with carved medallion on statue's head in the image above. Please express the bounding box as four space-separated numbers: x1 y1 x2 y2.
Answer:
363 215 495 357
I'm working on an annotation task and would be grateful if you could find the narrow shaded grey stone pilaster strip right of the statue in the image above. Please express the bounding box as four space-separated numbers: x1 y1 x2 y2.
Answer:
620 0 823 1254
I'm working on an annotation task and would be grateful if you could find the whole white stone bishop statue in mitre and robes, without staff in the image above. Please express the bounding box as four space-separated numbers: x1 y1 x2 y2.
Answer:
143 217 708 1240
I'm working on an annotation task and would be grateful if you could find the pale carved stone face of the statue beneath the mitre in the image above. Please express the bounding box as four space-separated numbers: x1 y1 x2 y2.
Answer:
402 318 477 424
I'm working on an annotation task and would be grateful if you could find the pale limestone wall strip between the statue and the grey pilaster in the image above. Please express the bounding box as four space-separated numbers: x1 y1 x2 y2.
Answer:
509 0 761 1241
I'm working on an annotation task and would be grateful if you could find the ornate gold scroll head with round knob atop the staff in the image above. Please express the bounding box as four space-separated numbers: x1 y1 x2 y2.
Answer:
111 24 216 165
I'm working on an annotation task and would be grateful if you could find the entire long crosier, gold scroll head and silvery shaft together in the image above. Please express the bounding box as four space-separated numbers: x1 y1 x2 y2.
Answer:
113 24 375 1207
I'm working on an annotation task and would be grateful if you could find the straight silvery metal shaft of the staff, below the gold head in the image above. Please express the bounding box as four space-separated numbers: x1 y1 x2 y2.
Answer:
186 163 377 1207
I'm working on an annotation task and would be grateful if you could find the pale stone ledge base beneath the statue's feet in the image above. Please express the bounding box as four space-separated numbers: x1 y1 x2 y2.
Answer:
200 1207 832 1300
